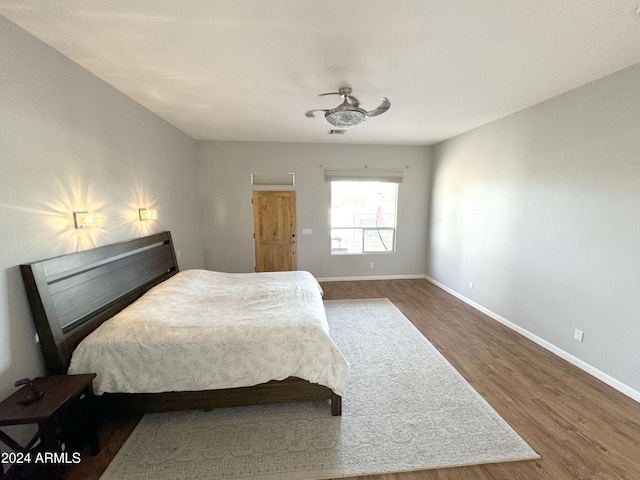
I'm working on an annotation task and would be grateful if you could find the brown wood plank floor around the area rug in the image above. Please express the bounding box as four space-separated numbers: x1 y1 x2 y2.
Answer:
65 280 640 480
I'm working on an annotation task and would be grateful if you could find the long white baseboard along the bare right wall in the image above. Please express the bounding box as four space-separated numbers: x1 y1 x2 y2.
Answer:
424 275 640 403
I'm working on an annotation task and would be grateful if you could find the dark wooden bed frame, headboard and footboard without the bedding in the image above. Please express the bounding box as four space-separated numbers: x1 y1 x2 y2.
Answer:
20 232 342 415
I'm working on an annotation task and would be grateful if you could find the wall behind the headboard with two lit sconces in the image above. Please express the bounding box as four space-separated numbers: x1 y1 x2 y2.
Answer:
0 16 204 424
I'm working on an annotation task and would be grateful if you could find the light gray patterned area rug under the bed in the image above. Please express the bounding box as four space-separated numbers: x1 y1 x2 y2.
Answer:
102 299 538 480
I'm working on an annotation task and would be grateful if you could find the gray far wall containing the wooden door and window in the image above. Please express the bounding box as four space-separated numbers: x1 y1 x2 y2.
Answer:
199 142 430 278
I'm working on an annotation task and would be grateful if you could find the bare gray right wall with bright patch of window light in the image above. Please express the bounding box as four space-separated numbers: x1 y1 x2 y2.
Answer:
427 65 640 400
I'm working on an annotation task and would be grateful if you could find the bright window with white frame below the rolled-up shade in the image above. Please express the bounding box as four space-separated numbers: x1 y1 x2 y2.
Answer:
331 181 398 255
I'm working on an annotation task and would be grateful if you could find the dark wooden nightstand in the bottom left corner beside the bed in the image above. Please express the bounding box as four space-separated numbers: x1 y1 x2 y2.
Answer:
0 373 100 478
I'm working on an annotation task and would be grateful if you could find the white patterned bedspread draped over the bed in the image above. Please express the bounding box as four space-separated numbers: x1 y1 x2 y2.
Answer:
69 270 349 395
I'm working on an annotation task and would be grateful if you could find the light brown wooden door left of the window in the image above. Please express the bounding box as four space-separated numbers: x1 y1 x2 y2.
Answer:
252 191 298 272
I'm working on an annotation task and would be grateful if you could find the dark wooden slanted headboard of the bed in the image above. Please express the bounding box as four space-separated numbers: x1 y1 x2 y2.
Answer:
20 232 178 375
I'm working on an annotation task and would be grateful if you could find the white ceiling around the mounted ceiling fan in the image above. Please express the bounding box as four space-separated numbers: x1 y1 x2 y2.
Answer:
0 0 640 145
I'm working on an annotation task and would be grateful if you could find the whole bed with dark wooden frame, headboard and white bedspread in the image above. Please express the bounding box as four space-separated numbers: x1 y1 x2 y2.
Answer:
21 232 348 415
